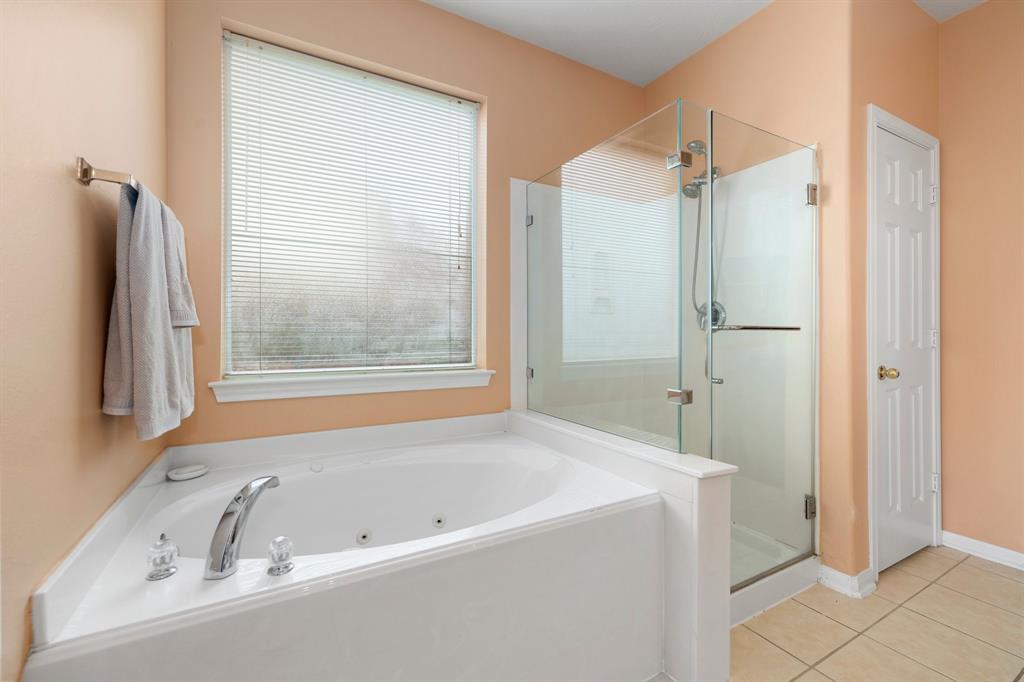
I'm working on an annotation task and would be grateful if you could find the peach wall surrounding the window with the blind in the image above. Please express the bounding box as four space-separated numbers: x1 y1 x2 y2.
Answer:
161 0 643 443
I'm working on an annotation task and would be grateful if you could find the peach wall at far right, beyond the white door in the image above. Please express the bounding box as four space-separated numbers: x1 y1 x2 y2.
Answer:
939 0 1024 552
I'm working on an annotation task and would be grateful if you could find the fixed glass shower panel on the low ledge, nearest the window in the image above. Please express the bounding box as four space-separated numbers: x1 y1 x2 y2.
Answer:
526 101 703 451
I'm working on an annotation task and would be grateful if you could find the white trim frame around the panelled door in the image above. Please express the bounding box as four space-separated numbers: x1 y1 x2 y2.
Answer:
866 104 942 580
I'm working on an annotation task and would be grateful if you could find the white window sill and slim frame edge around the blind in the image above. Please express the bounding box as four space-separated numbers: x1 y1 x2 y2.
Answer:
208 32 495 402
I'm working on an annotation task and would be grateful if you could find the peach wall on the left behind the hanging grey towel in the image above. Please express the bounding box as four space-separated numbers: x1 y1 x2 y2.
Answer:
0 2 166 680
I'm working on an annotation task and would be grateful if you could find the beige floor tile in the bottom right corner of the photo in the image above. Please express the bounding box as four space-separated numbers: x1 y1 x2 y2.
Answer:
864 608 1024 682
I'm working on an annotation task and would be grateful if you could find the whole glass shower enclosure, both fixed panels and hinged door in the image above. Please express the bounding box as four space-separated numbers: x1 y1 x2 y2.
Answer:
526 100 817 590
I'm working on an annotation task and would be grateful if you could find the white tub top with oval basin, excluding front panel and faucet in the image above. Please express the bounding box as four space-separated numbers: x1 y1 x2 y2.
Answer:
37 434 657 648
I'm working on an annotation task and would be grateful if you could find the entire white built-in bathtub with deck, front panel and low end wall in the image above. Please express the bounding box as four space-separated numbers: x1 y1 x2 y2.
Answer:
26 413 735 682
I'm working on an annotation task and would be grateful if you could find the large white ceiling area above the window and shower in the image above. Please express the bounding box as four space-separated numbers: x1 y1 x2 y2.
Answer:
424 0 770 85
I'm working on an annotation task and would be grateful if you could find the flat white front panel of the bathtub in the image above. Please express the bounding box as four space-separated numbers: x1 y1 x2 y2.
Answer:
25 499 664 682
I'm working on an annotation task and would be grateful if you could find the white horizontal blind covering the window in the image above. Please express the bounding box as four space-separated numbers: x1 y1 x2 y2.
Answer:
223 33 479 375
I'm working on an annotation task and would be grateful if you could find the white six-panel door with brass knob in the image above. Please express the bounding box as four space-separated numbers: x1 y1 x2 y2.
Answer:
869 119 938 570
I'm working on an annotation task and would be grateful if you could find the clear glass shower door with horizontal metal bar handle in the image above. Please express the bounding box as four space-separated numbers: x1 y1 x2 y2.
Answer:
697 112 817 590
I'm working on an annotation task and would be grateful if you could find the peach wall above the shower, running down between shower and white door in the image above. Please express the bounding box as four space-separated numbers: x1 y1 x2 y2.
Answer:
644 0 867 573
